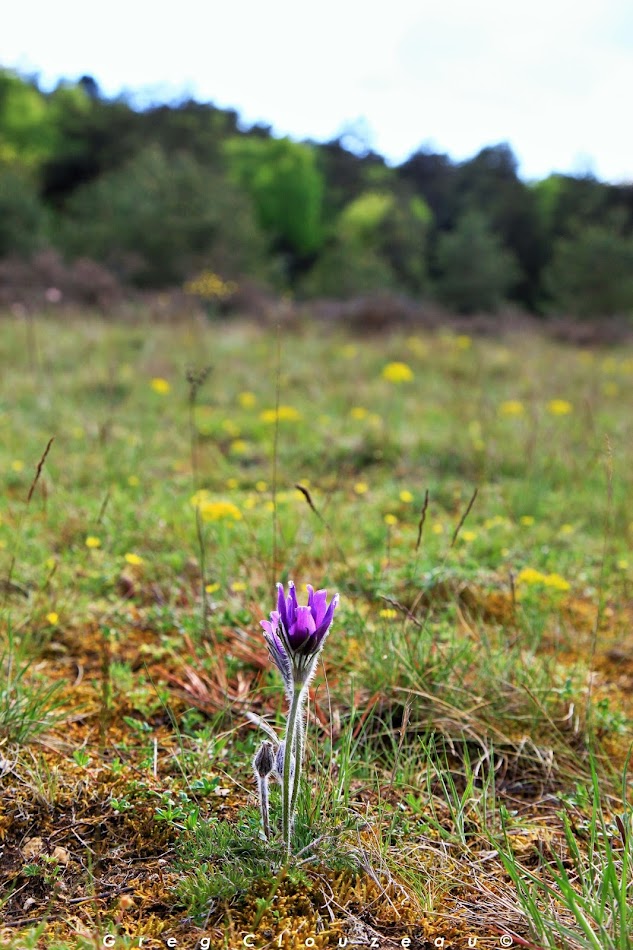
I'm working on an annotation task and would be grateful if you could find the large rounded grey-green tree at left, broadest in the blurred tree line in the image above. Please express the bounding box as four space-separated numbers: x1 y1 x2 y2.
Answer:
60 146 264 286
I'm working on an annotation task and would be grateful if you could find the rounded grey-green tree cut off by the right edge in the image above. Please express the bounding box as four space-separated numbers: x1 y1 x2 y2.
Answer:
545 225 633 317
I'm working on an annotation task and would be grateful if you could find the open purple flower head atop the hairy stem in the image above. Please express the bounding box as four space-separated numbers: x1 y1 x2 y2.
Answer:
261 581 338 686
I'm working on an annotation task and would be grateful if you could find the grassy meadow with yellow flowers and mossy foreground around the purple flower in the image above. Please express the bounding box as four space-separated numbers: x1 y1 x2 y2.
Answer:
0 314 633 950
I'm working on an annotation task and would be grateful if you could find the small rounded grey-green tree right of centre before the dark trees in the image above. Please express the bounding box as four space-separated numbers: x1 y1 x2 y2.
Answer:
437 211 518 313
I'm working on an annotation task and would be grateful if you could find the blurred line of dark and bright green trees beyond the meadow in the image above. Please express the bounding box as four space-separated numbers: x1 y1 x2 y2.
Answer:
0 70 633 318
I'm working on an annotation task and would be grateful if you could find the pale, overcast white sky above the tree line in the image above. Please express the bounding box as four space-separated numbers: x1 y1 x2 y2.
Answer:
0 0 633 182
